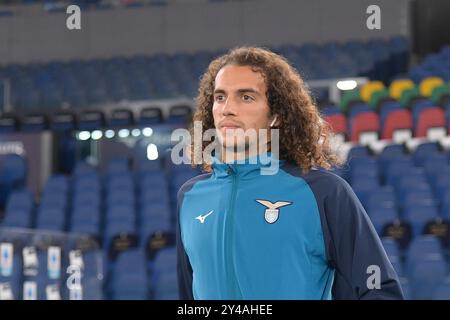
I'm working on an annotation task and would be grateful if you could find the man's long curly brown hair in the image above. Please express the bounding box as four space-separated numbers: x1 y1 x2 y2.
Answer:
189 47 341 173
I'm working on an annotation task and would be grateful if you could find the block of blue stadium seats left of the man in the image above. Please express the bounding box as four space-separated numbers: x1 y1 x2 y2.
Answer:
0 158 192 299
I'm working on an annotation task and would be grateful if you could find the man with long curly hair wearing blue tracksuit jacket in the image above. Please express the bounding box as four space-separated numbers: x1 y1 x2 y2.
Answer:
177 47 403 299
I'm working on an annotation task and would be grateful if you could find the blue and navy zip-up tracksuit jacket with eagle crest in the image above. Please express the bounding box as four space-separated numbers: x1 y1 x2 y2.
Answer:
177 153 403 299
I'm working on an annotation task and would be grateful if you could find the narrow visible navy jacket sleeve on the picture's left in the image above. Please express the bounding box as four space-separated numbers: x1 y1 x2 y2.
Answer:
176 182 194 300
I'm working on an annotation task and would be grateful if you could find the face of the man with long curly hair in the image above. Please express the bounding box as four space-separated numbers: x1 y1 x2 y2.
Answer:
213 65 270 152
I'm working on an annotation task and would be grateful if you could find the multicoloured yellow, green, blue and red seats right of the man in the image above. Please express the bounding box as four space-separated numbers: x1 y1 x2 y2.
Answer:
322 77 450 142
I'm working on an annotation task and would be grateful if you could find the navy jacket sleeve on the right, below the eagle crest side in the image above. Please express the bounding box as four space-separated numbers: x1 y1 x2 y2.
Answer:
306 173 403 299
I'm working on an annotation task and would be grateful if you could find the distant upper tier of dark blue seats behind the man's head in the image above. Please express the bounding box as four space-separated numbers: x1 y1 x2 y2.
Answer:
0 38 409 112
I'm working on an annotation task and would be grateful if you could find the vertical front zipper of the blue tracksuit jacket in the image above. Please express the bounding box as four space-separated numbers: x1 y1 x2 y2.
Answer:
225 167 242 299
